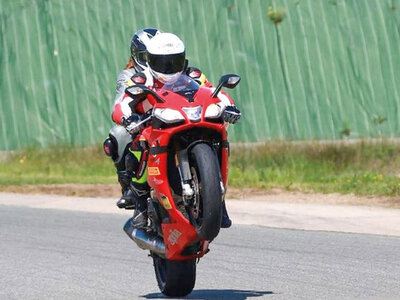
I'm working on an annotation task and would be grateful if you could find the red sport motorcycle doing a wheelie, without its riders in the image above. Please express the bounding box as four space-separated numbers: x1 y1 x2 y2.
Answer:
124 74 240 297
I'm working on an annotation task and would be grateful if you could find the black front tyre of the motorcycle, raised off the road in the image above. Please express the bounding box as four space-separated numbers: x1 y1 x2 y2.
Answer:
190 144 222 241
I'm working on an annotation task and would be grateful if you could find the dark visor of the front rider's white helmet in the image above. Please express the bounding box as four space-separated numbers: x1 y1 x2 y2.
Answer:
147 52 185 74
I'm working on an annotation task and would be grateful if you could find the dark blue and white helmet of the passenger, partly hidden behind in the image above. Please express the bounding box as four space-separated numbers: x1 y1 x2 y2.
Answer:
131 28 161 72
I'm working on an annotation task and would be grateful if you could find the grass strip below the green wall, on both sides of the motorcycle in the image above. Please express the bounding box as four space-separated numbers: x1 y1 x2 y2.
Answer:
0 142 400 197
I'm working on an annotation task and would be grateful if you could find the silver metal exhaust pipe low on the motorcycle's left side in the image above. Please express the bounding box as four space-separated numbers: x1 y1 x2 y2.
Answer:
124 219 165 258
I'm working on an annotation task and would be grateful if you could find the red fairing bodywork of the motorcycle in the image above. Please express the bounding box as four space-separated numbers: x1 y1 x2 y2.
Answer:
138 77 234 260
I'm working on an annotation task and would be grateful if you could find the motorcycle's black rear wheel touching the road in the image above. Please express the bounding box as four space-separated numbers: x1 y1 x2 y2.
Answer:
152 253 196 297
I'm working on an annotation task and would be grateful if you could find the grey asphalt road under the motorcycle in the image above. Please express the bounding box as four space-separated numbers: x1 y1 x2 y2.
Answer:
0 205 400 300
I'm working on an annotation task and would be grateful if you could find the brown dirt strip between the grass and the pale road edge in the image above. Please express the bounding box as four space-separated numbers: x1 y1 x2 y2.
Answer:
0 184 400 209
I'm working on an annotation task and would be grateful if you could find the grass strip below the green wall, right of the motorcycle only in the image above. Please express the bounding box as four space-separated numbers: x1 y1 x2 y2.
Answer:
230 142 400 196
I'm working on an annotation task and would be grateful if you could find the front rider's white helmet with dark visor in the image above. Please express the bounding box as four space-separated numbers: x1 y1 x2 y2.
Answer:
147 32 185 84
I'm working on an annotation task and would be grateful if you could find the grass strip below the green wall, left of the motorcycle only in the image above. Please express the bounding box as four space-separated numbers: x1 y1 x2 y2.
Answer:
0 146 117 185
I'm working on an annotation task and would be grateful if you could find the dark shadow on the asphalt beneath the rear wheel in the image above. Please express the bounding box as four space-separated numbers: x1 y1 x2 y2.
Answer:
142 290 274 300
